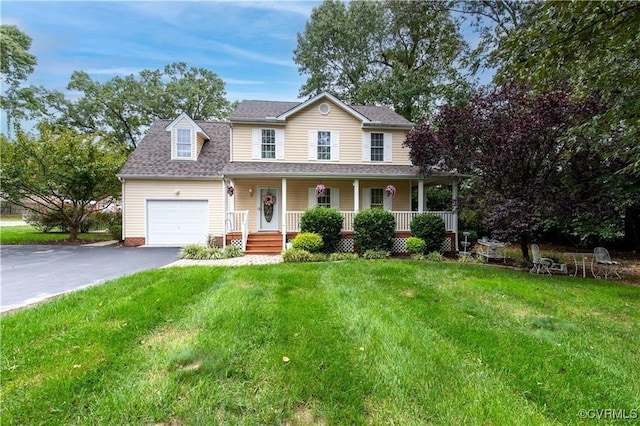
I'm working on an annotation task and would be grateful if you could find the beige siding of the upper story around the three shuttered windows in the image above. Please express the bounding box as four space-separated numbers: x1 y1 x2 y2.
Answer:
232 99 411 164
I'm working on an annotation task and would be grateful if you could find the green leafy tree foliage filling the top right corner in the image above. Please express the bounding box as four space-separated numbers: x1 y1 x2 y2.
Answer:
497 1 640 175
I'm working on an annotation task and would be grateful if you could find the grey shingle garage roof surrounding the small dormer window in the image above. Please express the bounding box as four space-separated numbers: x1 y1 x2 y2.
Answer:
118 120 229 178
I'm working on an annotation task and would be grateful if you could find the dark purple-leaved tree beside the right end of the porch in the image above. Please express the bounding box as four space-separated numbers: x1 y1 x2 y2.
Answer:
405 84 598 259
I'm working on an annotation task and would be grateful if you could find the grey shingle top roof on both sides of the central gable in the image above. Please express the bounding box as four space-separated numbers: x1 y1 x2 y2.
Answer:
229 100 412 126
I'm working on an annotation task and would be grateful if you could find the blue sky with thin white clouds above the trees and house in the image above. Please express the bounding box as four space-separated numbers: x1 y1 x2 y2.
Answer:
1 0 320 101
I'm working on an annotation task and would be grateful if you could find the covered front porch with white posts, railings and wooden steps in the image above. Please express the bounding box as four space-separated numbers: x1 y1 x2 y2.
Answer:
222 176 460 253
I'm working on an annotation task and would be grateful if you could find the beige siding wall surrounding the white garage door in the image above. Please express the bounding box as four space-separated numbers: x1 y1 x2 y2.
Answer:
123 179 223 238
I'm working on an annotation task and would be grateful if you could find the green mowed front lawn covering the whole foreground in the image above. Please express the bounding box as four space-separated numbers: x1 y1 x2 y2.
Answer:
0 260 640 425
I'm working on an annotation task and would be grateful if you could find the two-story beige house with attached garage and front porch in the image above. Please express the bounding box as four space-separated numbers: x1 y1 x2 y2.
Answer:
118 93 462 253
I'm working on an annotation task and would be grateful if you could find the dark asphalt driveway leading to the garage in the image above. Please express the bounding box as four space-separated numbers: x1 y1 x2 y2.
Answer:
0 245 179 312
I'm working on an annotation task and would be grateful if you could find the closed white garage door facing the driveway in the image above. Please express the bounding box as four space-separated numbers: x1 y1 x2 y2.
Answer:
147 200 209 246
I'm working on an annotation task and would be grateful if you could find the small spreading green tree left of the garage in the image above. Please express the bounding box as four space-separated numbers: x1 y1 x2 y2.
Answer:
0 123 125 240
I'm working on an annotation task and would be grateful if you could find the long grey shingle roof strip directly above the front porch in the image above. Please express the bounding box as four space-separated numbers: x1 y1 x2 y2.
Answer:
222 161 463 178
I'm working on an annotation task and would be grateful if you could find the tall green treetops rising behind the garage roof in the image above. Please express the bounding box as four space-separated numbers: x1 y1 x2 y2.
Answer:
42 62 233 148
